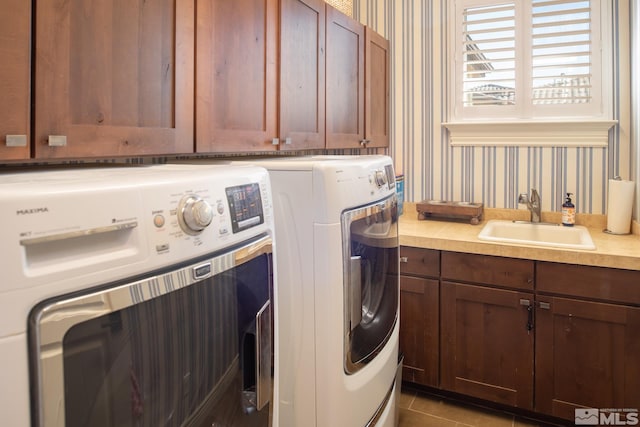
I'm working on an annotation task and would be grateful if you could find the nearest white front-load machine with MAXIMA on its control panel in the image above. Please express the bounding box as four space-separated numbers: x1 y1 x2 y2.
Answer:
0 165 277 427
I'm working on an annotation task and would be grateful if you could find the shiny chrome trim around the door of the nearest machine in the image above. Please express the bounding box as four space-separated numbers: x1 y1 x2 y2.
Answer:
31 235 273 427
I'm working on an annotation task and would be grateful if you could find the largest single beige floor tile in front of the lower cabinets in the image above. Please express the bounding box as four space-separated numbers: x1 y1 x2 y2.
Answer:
402 394 513 427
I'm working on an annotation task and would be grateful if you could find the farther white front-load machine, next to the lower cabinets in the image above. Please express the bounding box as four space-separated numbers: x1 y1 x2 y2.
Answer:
240 155 400 427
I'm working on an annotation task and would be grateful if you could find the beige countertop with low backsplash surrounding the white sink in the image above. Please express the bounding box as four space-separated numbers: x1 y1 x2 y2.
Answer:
400 202 640 270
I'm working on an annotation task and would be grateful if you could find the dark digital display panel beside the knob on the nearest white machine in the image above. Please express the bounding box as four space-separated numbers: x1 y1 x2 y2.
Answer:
225 182 264 233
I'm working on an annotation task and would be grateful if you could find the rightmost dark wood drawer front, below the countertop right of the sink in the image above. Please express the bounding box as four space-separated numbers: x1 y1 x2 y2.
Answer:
536 262 640 304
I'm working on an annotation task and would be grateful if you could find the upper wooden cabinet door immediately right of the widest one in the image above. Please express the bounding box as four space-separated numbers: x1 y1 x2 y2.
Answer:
196 0 278 152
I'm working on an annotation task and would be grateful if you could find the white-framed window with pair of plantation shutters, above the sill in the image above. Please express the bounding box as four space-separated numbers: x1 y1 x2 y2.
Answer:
451 0 606 121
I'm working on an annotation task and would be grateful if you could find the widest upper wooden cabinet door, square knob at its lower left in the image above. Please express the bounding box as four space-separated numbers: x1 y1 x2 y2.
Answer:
34 0 195 158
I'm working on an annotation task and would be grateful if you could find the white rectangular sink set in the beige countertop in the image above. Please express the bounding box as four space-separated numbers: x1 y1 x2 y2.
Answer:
478 220 596 250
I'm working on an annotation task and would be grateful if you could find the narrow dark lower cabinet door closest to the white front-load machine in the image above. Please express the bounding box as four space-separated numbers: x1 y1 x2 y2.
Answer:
400 276 440 387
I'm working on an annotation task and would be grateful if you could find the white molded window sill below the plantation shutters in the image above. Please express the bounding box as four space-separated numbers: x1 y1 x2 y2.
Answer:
442 120 618 147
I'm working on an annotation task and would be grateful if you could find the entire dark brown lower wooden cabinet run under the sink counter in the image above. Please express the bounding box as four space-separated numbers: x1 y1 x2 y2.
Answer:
400 247 640 423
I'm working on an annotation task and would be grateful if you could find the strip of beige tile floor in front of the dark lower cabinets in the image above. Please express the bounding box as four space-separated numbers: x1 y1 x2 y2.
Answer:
399 388 568 427
